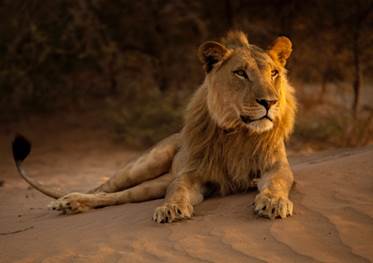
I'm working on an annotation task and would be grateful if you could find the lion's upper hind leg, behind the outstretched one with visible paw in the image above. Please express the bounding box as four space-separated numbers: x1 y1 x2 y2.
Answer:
88 134 179 193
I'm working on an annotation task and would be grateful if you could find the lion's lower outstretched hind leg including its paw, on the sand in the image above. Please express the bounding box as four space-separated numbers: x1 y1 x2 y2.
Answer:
49 174 172 214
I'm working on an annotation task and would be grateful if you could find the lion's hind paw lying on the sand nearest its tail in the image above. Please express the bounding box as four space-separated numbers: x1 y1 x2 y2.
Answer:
48 193 91 214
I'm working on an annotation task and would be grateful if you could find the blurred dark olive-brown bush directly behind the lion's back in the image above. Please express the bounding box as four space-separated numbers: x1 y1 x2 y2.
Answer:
106 94 183 147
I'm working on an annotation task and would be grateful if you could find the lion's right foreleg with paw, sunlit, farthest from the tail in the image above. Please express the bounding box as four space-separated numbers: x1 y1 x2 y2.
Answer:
255 162 294 219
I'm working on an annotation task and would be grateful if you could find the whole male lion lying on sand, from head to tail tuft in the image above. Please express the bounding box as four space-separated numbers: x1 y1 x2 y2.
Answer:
13 32 296 223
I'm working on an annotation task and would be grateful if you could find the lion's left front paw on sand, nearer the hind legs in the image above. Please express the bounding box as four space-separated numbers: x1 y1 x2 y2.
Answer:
153 203 193 224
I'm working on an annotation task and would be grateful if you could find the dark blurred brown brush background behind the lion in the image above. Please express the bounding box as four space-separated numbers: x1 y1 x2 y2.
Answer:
0 0 373 152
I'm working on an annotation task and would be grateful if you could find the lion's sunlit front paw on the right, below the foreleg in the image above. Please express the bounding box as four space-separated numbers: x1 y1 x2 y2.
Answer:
254 191 293 219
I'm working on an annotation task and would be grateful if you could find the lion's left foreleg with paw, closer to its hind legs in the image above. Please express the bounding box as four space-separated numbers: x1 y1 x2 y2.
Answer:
153 175 203 223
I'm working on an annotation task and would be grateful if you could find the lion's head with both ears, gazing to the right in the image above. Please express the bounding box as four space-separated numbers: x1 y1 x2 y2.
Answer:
198 32 293 134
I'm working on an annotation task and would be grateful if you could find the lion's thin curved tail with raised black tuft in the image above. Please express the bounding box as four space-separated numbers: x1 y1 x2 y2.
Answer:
12 135 65 199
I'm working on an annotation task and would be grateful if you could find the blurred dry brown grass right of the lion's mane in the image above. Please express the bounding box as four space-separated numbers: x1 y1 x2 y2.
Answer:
292 83 373 150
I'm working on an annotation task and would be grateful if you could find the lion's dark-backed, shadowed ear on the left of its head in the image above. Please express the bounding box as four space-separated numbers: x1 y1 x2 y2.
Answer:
198 41 228 73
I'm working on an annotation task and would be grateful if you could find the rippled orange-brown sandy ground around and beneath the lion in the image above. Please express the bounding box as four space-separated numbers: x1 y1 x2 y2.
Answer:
0 117 373 262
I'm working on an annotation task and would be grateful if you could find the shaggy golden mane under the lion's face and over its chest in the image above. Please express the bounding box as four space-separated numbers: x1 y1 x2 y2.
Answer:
182 68 296 194
